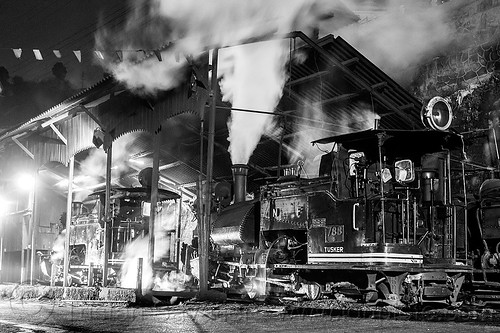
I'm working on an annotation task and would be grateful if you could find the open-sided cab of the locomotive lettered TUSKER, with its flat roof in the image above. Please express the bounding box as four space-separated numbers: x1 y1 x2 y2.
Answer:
308 130 462 266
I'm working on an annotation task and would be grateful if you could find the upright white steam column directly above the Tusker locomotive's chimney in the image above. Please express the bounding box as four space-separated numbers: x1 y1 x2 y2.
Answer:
219 40 288 164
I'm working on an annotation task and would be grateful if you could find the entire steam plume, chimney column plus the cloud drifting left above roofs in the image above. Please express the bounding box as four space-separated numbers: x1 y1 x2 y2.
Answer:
97 0 338 163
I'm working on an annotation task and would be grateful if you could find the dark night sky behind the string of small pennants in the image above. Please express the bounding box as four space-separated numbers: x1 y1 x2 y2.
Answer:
0 0 128 89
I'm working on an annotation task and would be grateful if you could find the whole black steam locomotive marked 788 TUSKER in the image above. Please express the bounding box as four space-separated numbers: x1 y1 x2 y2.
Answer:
211 100 500 306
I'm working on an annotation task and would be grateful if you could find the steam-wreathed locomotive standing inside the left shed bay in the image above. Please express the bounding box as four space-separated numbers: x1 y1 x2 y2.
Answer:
43 185 179 287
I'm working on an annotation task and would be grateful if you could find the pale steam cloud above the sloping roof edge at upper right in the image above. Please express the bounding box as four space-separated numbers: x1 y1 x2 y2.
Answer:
335 0 455 84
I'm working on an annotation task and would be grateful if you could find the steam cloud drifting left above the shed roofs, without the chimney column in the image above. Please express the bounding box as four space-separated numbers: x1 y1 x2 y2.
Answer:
96 0 328 93
